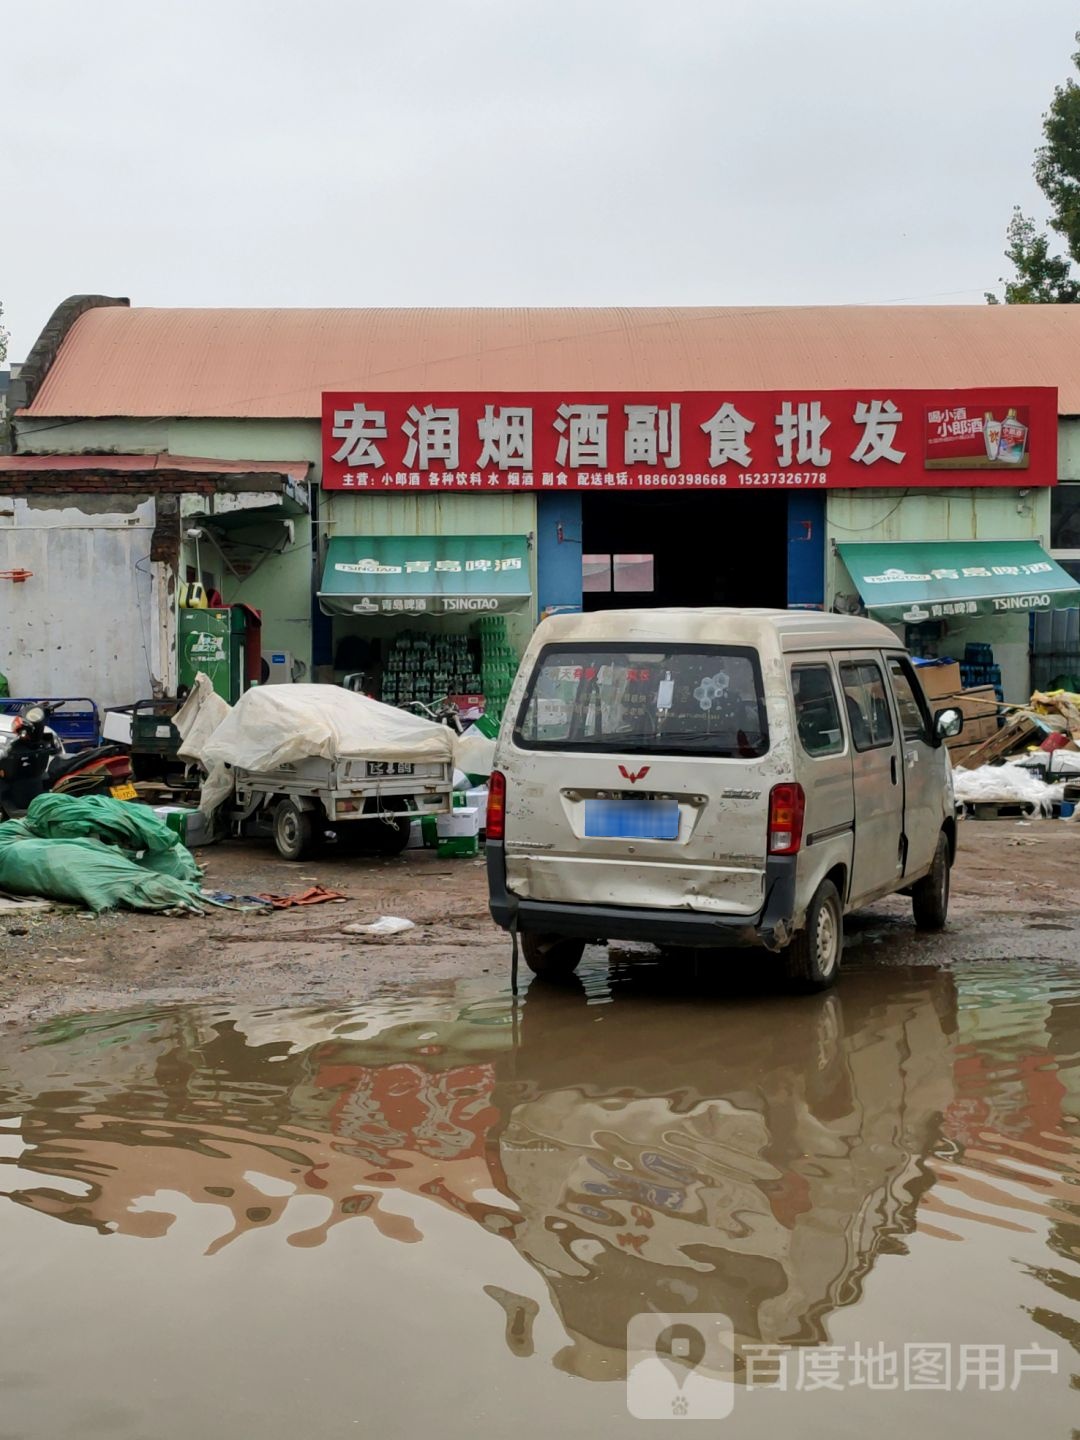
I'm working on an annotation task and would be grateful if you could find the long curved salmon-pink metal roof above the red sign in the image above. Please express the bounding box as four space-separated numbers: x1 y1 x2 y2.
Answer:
19 305 1080 418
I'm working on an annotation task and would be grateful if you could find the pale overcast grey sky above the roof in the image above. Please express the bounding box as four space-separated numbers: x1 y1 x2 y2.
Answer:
0 0 1080 360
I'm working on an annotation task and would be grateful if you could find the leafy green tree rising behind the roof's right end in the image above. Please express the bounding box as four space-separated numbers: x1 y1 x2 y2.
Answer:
986 30 1080 305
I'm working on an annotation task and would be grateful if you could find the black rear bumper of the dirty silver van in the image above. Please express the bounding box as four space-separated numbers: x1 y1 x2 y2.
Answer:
487 841 795 950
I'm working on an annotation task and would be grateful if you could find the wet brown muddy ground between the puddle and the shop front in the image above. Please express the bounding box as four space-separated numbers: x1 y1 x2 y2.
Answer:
0 821 1080 1025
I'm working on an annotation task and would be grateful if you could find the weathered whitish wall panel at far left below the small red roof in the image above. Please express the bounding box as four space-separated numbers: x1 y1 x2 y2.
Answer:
0 497 164 706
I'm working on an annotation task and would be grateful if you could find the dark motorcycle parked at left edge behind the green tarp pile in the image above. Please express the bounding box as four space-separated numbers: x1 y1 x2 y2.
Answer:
0 704 135 819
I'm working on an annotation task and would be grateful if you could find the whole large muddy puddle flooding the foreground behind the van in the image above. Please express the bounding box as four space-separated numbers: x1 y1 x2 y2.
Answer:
0 962 1080 1440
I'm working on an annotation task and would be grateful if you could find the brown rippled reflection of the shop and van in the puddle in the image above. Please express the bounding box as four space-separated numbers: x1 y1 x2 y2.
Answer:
0 966 1080 1422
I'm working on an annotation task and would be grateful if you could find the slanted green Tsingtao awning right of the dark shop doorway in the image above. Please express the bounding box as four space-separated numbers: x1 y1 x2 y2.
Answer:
837 540 1080 625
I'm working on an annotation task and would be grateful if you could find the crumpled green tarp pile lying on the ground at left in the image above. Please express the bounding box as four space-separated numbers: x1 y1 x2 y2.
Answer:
0 795 203 913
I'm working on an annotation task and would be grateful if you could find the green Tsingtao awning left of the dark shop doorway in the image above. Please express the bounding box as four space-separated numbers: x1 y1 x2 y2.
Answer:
318 536 531 616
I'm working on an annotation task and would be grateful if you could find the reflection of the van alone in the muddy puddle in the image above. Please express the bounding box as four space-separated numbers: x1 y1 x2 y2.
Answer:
497 972 956 1378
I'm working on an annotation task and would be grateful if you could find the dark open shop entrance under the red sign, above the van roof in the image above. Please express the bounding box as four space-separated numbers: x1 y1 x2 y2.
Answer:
582 490 788 611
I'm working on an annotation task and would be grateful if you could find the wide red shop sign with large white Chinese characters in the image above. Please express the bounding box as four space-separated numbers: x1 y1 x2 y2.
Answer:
323 386 1057 492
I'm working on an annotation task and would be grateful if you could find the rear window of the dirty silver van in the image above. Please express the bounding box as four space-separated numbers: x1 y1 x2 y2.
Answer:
514 645 769 757
